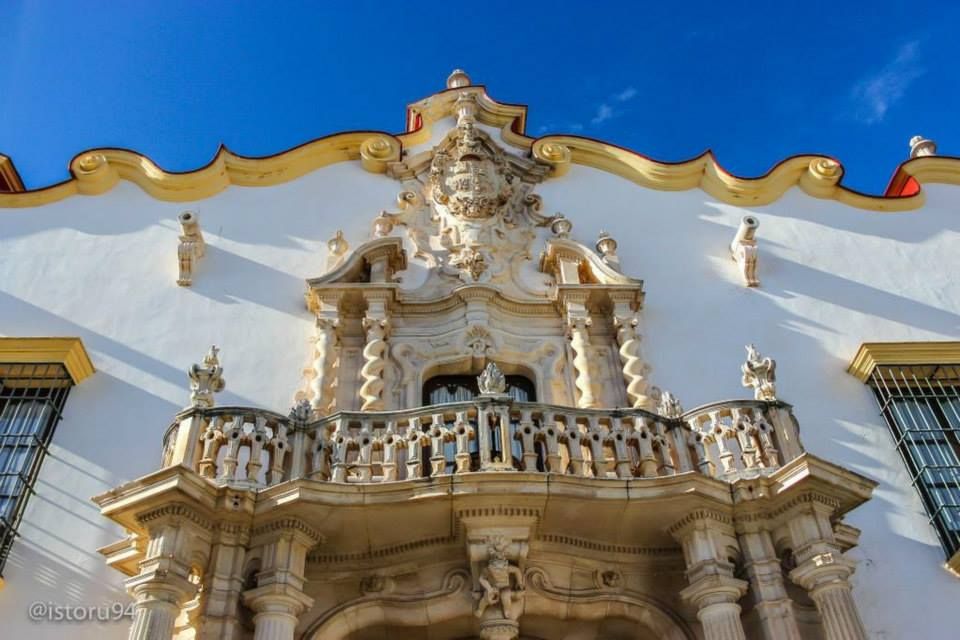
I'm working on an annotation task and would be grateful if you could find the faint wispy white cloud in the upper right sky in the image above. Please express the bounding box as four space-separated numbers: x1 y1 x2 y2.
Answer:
851 40 926 124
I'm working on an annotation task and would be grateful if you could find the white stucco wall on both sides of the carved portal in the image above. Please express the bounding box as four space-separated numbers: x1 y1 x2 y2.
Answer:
0 121 960 640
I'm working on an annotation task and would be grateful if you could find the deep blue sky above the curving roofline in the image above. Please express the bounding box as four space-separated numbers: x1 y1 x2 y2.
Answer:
0 0 960 192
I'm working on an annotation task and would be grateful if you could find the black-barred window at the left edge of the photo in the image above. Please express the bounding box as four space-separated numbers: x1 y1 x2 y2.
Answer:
0 363 72 575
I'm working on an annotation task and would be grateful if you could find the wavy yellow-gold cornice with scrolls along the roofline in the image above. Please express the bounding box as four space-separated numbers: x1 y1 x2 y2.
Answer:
0 79 960 212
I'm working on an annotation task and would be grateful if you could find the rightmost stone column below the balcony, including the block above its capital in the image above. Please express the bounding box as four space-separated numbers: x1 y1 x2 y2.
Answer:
783 495 867 640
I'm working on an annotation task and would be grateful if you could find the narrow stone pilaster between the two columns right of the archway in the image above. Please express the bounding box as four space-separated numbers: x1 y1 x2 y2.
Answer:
737 520 802 640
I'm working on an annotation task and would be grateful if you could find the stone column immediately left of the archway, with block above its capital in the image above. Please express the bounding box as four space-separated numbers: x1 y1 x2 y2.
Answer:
243 518 322 640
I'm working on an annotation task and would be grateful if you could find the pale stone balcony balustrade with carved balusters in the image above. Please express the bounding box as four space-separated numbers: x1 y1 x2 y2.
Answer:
163 397 802 487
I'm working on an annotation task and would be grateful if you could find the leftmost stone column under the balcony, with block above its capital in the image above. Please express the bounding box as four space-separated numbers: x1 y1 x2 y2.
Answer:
125 504 210 640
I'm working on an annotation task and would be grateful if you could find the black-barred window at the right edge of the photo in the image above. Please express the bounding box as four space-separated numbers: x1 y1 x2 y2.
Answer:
870 365 960 558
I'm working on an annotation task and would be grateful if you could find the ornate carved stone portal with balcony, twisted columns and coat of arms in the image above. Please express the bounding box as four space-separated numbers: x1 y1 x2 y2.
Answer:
96 71 874 640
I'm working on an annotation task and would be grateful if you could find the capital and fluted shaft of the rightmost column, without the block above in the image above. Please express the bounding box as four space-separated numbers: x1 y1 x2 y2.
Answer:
790 551 867 640
